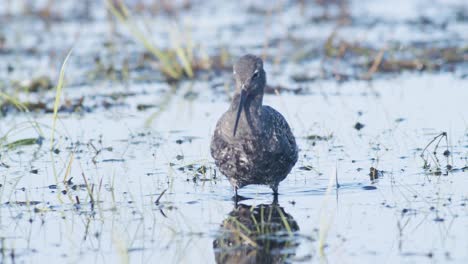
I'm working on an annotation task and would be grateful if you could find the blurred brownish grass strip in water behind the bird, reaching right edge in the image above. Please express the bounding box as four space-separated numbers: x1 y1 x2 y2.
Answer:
320 29 468 80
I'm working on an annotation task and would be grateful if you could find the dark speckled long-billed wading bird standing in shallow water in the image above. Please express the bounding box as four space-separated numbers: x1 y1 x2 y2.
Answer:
211 55 298 194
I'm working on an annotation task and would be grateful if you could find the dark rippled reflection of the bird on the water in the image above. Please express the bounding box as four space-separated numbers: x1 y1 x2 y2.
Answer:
213 201 299 263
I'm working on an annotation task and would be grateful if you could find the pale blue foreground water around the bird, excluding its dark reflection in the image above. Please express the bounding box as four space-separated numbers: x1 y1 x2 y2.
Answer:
1 74 468 262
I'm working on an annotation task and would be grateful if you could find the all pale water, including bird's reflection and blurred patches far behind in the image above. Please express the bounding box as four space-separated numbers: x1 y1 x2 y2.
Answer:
0 1 468 263
